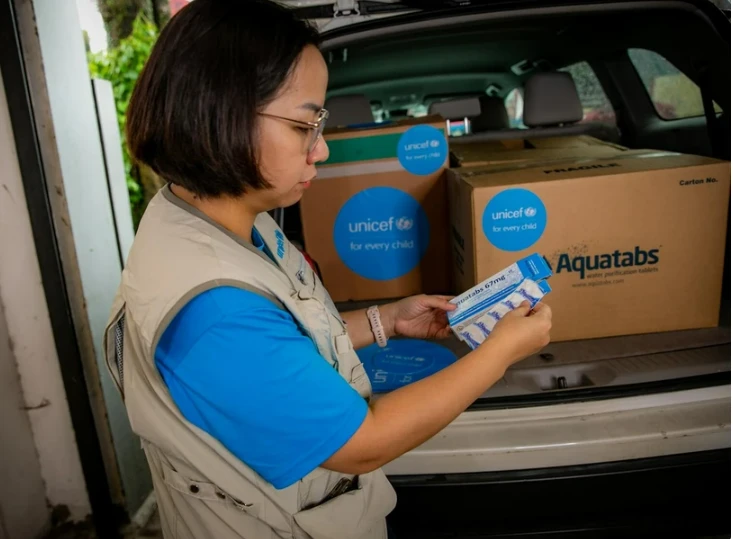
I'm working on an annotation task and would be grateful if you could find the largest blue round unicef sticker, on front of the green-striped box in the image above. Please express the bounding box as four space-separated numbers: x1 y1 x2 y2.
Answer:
333 187 430 281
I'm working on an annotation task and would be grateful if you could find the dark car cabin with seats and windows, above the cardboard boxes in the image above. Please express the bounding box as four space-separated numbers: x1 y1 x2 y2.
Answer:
318 5 730 151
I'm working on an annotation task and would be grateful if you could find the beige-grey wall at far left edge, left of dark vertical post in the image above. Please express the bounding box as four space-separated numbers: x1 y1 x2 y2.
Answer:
0 68 90 528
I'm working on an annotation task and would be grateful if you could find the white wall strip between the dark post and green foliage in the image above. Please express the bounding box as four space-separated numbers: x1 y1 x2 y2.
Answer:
15 0 152 513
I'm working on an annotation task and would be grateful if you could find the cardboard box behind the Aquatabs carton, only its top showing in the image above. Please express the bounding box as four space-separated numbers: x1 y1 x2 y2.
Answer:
451 136 627 167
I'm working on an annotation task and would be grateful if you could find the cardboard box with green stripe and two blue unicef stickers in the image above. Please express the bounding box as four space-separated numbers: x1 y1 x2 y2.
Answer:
300 117 450 301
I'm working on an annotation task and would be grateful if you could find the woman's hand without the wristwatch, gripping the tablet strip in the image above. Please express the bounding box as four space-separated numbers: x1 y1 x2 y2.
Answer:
479 301 552 367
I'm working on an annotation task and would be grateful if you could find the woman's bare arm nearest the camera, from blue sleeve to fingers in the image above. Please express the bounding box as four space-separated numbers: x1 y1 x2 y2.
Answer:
323 303 552 474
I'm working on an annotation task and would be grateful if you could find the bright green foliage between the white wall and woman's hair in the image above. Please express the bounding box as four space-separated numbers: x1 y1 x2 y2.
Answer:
87 13 158 228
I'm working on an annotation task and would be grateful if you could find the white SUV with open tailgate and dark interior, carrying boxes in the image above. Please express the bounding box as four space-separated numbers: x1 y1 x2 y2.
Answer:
283 0 731 538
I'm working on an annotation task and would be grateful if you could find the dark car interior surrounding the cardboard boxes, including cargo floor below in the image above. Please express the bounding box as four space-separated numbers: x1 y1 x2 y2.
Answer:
283 2 730 408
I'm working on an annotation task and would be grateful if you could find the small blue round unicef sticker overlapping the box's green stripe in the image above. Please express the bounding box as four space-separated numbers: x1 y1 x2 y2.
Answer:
397 125 448 176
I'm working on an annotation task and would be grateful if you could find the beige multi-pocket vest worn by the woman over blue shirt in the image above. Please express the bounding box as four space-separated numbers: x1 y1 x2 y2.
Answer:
104 187 396 539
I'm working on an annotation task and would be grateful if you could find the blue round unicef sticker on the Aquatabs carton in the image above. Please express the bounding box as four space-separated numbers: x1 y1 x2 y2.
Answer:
482 189 547 251
